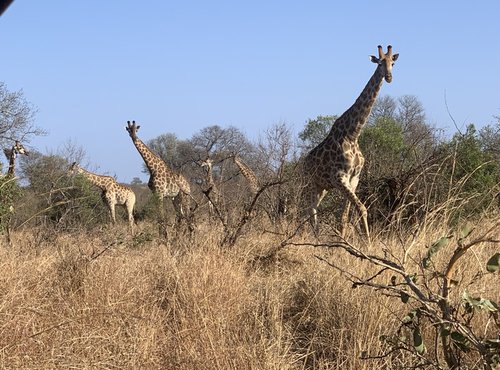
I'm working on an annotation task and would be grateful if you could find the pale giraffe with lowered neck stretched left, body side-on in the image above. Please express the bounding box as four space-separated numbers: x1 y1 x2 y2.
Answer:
69 162 135 231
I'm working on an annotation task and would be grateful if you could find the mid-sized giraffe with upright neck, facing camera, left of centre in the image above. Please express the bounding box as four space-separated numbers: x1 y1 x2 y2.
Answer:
125 121 191 235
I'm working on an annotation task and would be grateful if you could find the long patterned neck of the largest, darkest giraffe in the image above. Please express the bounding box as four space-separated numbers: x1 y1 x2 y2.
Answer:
329 66 384 141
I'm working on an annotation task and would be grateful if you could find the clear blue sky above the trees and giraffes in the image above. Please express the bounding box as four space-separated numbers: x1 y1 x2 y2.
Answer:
0 0 500 182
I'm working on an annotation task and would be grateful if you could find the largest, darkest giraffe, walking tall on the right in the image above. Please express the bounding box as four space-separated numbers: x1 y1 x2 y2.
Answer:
302 45 399 240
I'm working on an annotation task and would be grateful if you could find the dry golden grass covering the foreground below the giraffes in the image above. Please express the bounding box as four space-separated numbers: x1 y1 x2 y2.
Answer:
0 217 500 369
